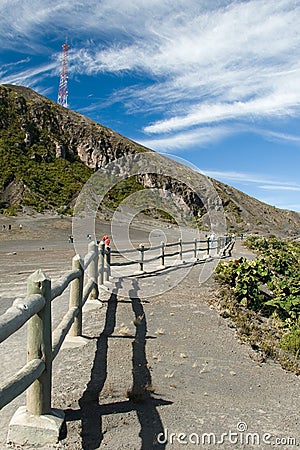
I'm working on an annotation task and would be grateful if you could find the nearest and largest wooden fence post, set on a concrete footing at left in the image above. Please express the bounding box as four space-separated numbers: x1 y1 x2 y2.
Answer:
26 270 52 416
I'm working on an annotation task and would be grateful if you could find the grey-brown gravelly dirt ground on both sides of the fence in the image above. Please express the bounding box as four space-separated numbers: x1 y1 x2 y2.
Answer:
0 218 300 450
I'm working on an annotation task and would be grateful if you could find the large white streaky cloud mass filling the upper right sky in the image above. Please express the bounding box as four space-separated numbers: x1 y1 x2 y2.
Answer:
74 0 300 133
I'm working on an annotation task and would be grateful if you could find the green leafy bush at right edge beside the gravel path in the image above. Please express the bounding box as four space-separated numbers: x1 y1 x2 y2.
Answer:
216 236 300 371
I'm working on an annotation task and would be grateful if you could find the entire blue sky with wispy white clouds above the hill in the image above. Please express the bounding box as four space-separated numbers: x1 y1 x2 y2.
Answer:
0 0 300 211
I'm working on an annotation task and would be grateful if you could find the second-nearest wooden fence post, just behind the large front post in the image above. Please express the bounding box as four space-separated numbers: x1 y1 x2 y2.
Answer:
69 255 84 336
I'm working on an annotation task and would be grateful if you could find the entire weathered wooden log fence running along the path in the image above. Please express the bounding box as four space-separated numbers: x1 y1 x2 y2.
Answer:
0 236 234 444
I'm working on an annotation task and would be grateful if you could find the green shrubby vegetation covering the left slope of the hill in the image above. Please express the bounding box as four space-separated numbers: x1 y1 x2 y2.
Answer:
0 88 93 214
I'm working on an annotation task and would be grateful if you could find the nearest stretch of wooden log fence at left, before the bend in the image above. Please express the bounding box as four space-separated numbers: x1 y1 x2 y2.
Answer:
0 243 98 415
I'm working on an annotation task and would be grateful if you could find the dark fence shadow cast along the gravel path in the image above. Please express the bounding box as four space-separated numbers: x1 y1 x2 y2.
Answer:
65 280 172 450
